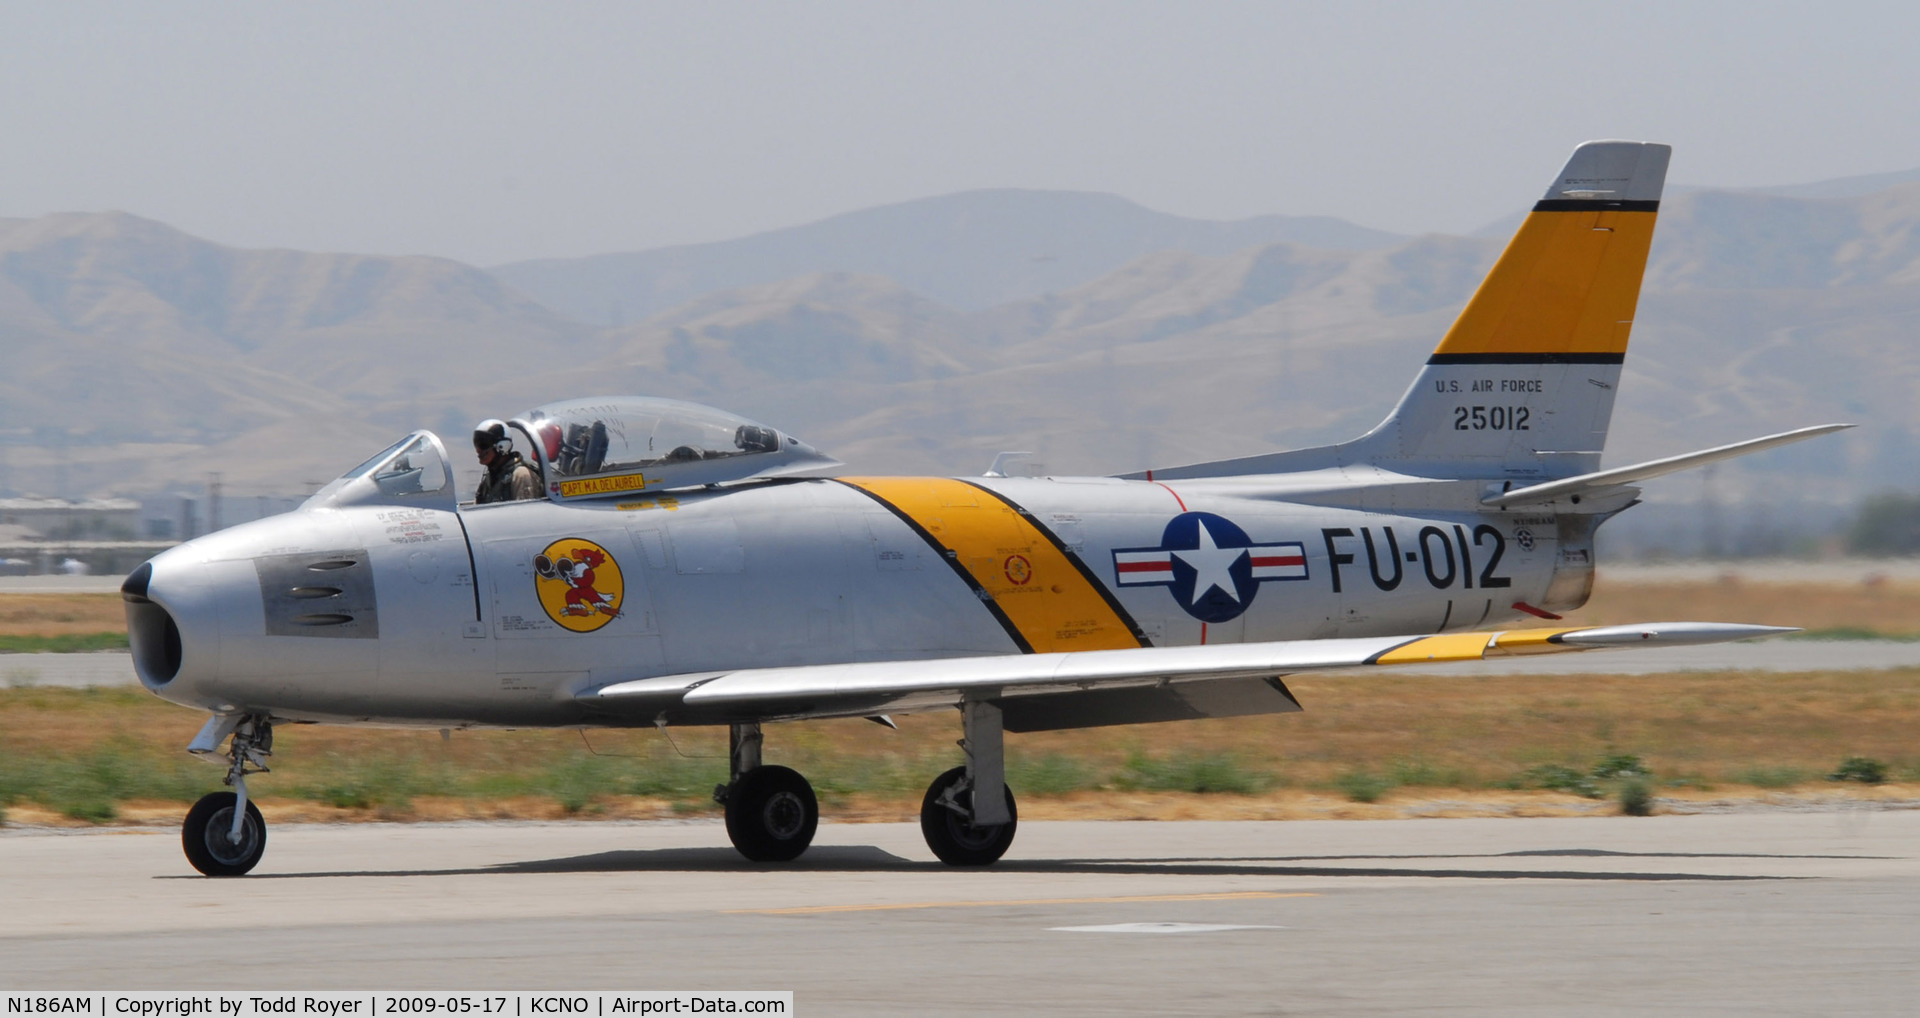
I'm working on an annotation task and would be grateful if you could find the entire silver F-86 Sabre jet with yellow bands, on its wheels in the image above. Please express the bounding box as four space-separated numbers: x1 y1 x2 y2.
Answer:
123 142 1845 876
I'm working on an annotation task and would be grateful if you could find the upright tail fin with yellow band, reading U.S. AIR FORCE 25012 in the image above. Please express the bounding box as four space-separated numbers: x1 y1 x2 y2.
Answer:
1135 140 1672 480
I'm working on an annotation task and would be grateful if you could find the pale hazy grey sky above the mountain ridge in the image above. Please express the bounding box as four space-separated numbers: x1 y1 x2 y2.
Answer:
0 0 1920 265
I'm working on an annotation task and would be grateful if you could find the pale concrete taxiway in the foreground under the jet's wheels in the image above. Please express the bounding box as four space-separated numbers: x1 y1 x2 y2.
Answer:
0 811 1920 1016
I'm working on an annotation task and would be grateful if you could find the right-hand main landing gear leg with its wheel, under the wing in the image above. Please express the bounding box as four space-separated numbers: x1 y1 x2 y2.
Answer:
920 701 1020 866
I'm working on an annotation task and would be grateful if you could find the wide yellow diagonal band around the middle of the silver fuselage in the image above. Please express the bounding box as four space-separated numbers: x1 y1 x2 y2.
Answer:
839 476 1142 653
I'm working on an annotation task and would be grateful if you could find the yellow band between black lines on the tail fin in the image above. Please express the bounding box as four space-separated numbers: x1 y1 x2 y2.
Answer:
1434 209 1659 355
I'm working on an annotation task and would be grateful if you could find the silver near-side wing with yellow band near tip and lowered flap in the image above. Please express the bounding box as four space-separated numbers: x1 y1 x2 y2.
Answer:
578 622 1795 732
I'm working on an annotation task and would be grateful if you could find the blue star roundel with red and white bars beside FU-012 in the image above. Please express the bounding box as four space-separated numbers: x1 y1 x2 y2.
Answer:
1114 513 1308 622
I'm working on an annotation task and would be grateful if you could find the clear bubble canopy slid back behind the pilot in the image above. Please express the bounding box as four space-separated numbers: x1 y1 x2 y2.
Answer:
511 396 841 501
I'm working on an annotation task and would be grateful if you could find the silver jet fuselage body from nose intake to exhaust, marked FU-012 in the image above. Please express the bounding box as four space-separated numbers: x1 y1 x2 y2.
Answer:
134 471 1594 726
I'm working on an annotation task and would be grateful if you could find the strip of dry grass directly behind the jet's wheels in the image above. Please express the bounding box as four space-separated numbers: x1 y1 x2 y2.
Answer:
0 668 1920 820
